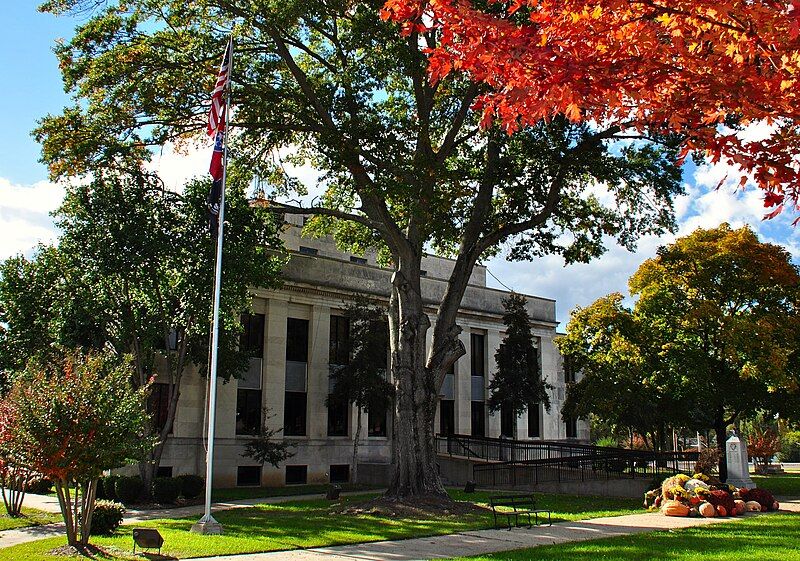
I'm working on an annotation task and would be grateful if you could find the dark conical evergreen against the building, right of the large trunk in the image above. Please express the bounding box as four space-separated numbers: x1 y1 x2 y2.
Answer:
489 293 550 436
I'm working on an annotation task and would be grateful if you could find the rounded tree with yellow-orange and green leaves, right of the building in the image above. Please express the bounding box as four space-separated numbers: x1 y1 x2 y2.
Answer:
560 224 800 478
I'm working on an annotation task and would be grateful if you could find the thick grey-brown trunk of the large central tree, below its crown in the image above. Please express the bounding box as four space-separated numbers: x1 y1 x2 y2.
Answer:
387 268 447 499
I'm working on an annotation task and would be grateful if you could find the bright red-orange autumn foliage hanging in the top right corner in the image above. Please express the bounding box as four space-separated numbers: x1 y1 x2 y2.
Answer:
383 0 800 217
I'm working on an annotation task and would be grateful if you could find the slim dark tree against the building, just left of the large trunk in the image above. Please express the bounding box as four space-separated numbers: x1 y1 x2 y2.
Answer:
326 296 394 482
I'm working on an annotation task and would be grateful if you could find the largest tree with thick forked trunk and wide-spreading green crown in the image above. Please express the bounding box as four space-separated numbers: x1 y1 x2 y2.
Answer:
35 0 682 499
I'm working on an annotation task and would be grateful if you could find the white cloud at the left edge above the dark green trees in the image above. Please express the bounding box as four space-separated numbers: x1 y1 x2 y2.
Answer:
0 177 64 259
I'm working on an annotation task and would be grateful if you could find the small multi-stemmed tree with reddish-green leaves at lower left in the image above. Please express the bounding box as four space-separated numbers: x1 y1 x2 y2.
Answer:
5 353 155 548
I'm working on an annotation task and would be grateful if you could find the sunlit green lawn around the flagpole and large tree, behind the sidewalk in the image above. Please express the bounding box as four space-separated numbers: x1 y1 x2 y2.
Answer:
0 491 640 561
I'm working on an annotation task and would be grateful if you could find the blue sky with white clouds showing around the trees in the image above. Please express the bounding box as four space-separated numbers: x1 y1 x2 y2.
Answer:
0 4 800 330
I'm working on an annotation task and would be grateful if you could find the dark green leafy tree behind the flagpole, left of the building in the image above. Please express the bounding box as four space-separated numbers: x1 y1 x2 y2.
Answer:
0 173 281 489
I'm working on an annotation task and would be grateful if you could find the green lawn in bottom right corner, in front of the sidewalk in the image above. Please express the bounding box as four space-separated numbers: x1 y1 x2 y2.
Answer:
446 514 800 561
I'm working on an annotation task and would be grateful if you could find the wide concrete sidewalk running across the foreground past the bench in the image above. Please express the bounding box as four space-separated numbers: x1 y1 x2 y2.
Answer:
193 501 800 561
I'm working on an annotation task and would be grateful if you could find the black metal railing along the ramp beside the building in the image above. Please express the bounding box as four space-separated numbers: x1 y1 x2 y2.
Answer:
436 434 698 487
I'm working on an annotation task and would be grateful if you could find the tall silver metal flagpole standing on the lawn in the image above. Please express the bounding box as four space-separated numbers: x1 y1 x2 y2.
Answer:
192 34 233 534
